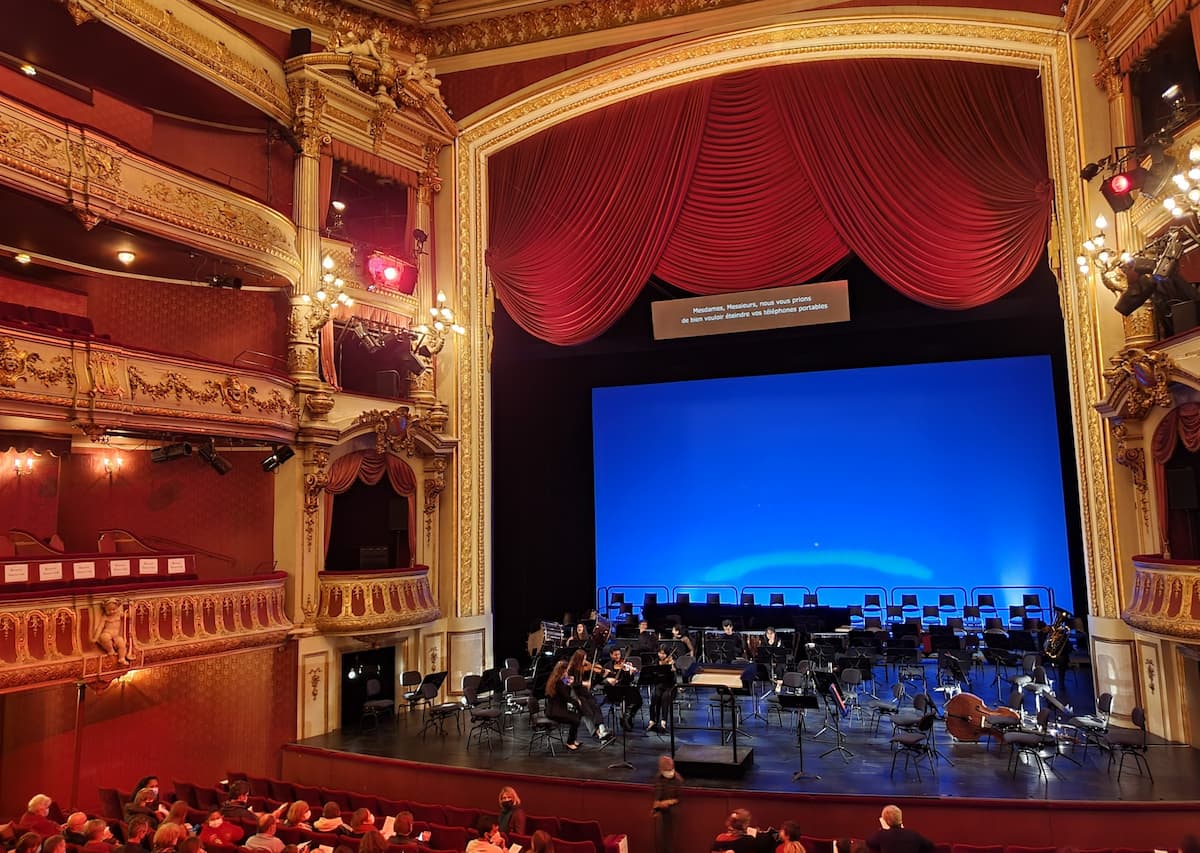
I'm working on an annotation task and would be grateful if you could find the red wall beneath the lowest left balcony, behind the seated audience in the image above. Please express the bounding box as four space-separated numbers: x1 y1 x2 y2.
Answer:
0 644 296 819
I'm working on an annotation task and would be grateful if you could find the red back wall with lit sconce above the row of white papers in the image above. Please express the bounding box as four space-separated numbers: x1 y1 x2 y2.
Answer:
59 451 275 578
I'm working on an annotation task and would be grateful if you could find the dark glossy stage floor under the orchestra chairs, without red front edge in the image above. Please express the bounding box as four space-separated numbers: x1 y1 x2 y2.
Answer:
299 669 1200 801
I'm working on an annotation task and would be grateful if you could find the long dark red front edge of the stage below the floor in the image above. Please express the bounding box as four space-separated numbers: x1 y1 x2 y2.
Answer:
281 744 1200 853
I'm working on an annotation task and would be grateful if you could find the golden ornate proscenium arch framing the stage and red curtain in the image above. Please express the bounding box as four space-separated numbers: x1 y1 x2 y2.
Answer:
455 10 1120 618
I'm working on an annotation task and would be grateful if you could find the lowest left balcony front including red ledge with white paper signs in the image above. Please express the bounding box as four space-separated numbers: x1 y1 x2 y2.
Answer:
0 566 292 692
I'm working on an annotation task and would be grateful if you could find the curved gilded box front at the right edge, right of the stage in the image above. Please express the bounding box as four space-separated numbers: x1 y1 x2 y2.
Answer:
1121 557 1200 642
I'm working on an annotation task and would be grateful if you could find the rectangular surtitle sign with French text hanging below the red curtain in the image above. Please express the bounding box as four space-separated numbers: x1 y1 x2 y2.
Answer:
650 281 850 341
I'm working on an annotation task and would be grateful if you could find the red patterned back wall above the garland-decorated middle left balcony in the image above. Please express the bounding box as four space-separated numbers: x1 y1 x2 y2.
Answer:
89 280 287 371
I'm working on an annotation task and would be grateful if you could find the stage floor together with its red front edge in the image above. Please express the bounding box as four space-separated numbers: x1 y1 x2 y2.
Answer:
283 671 1200 851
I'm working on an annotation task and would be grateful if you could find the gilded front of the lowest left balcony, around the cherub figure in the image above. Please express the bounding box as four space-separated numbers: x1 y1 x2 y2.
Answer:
0 573 292 693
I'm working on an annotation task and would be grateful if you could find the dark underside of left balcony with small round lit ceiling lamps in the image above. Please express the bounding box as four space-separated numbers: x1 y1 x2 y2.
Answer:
0 187 287 288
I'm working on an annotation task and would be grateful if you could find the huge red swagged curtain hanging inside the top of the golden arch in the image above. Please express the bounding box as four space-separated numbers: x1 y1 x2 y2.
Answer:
487 60 1051 344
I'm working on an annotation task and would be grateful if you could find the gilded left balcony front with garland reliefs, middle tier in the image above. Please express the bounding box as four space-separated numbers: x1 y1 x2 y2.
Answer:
0 326 300 441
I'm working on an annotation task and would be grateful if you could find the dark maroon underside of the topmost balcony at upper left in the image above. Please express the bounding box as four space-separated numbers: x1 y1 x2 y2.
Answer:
0 0 266 127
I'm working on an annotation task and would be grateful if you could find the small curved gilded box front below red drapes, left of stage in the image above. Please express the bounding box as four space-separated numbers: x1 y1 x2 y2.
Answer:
317 566 442 633
